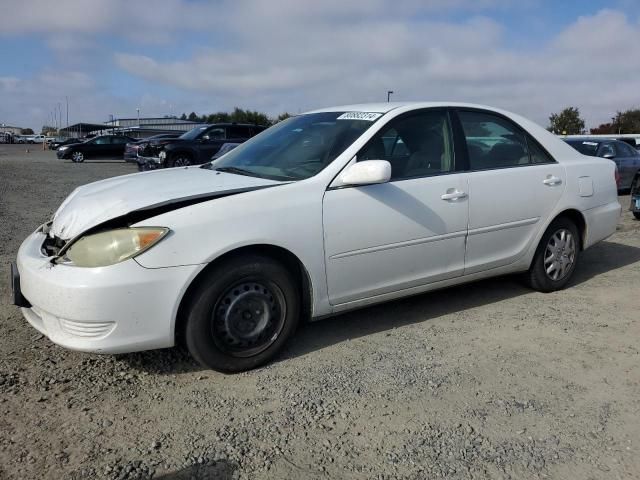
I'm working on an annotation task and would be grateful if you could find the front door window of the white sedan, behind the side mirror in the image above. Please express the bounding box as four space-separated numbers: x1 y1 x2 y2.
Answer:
357 110 454 181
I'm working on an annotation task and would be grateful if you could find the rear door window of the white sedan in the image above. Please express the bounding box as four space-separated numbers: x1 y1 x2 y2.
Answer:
458 111 528 170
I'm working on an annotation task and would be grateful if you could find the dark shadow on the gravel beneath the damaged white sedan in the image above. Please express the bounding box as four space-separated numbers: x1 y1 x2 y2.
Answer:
119 241 640 375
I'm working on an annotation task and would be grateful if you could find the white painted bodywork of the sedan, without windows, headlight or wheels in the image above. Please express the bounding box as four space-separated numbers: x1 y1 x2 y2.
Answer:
18 102 620 353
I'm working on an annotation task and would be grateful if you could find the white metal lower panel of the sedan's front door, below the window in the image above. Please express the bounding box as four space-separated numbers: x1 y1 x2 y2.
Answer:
323 173 469 305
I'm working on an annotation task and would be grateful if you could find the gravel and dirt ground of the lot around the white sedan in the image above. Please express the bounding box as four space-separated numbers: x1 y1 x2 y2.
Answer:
0 145 640 480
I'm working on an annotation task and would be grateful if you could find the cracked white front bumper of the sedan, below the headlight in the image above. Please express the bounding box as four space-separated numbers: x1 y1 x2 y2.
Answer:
17 232 199 353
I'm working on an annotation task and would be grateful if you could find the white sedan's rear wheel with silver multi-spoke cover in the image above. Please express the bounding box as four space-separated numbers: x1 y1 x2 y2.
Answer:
526 218 580 292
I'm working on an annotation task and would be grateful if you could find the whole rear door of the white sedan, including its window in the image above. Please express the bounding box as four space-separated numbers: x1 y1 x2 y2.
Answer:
457 109 566 275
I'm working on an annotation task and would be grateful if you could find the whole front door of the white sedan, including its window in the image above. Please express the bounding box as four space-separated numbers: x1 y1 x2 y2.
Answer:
323 109 468 305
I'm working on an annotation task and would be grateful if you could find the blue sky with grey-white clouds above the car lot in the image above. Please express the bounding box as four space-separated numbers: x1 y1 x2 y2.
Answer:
0 0 640 131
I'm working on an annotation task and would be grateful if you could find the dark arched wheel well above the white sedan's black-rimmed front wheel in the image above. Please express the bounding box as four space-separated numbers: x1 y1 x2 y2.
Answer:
174 244 313 343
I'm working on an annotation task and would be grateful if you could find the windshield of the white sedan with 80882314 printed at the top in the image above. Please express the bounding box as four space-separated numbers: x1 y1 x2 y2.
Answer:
203 112 382 180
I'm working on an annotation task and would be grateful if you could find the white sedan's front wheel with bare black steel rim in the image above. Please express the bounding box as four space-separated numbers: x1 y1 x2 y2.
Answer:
184 255 300 373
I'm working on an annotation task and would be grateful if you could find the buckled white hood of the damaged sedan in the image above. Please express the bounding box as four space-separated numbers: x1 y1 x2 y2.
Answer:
49 167 284 240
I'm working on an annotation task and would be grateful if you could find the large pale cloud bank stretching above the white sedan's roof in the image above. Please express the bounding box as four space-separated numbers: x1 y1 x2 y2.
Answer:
115 7 640 124
